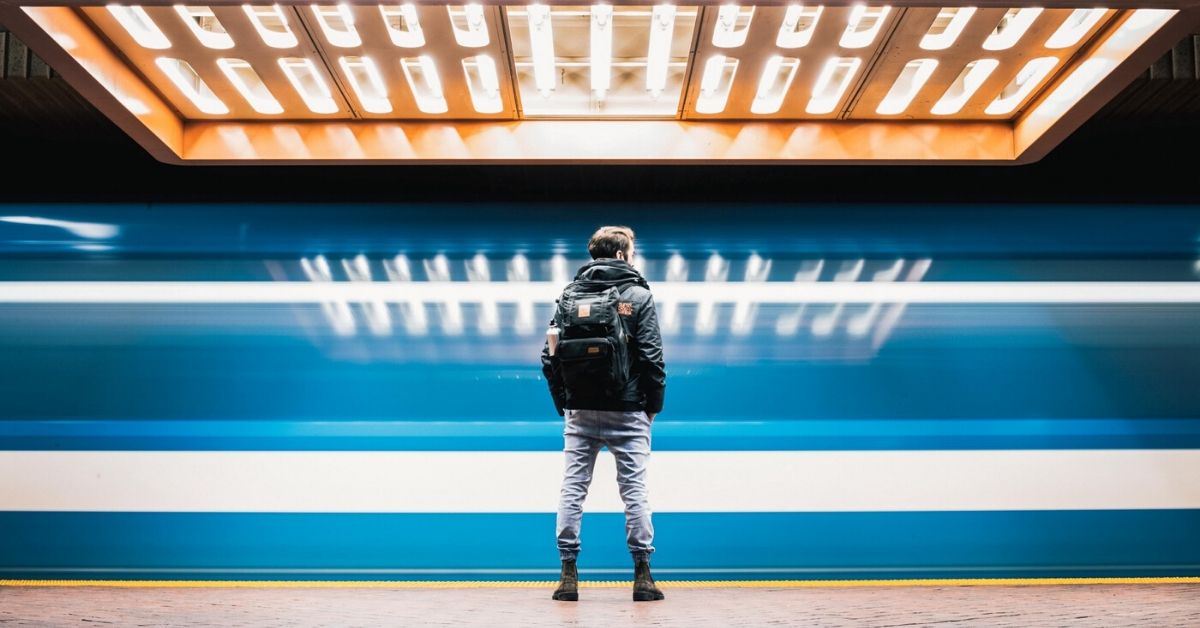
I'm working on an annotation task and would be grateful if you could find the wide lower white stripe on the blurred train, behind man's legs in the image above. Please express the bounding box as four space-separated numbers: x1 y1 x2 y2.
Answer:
0 449 1200 513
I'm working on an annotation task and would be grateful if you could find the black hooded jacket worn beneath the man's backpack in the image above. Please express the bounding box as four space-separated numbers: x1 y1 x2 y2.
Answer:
541 258 667 414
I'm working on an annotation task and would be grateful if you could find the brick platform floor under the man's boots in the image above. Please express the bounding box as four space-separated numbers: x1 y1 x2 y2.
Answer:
0 578 1200 628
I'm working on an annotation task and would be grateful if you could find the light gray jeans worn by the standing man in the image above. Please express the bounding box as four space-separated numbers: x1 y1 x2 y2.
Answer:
557 409 654 561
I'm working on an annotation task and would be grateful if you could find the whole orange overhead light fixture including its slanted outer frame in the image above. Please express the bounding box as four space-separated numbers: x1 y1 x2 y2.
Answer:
0 0 1200 163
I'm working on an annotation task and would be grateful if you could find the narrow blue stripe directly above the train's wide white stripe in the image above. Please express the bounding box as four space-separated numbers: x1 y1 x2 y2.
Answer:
0 419 1200 451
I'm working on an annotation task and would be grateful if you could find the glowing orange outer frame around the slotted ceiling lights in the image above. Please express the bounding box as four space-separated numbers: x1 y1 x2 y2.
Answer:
0 0 1200 165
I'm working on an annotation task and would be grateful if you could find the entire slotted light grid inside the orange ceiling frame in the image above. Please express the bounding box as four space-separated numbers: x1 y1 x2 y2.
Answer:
83 4 1117 120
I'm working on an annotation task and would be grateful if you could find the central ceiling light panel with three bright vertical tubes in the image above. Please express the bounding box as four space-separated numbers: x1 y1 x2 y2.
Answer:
506 5 700 118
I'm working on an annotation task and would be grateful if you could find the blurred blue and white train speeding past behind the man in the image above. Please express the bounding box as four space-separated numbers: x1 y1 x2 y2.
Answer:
0 204 1200 580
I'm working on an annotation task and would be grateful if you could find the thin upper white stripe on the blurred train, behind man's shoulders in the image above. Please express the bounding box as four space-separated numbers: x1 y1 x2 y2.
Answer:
0 281 1200 304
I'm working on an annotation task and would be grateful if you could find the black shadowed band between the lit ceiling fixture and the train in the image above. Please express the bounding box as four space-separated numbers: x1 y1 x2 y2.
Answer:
0 30 1200 204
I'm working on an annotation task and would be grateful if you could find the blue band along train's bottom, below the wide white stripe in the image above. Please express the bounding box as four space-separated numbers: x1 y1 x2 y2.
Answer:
0 510 1200 580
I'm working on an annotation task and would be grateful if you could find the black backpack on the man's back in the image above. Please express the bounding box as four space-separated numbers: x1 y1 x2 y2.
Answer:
554 280 634 399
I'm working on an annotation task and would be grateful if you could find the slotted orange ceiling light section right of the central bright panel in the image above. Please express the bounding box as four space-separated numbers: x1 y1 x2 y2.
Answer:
684 5 1117 120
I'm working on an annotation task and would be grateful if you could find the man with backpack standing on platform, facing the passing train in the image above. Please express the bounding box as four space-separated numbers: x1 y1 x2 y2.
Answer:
541 227 666 602
